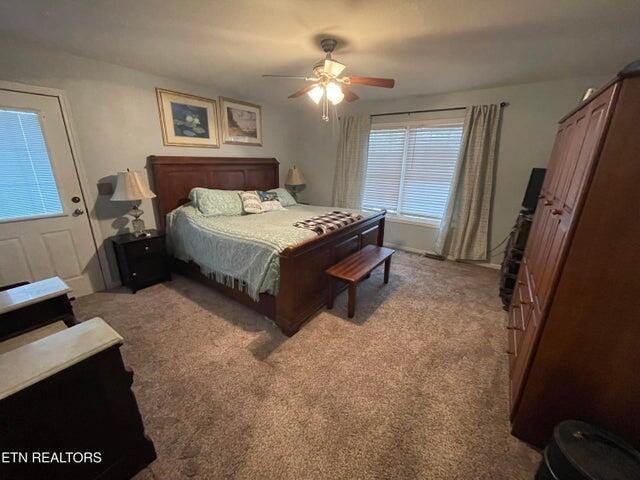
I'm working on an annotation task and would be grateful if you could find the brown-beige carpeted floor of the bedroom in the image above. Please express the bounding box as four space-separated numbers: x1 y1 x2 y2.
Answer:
74 252 539 480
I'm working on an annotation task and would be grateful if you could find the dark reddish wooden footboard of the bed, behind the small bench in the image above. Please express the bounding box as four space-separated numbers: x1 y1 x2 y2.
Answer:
274 212 385 335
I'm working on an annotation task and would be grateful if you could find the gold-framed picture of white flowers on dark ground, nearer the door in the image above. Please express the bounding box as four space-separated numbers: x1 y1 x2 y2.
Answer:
156 88 220 148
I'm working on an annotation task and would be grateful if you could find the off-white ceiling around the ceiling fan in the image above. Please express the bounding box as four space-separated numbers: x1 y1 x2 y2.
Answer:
0 0 640 102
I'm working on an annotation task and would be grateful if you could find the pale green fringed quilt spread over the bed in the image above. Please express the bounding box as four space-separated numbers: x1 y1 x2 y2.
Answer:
166 204 368 301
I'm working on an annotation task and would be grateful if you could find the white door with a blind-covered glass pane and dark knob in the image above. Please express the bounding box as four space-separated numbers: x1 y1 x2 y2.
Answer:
0 89 104 296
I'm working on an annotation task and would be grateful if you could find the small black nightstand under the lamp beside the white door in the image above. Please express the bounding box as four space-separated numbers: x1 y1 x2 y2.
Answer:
111 230 171 293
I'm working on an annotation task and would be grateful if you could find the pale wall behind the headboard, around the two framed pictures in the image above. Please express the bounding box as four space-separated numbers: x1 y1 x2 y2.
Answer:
0 37 296 286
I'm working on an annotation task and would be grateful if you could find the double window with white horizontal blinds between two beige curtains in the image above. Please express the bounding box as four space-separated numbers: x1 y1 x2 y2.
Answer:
363 119 463 221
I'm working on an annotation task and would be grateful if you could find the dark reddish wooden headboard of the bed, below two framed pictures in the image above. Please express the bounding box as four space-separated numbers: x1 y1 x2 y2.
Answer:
149 155 279 230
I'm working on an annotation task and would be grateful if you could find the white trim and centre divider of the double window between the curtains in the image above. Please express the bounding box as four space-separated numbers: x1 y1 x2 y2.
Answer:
363 118 466 228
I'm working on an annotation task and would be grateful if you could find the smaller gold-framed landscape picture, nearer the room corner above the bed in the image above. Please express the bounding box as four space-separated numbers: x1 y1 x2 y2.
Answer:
220 97 262 147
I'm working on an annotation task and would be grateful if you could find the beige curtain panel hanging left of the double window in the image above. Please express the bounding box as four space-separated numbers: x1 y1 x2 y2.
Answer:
333 115 371 208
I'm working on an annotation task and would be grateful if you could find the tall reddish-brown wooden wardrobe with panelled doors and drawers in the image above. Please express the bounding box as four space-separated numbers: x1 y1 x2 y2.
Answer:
507 62 640 447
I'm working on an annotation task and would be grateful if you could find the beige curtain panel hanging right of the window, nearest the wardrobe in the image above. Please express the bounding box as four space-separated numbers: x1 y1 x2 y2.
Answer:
435 105 502 260
